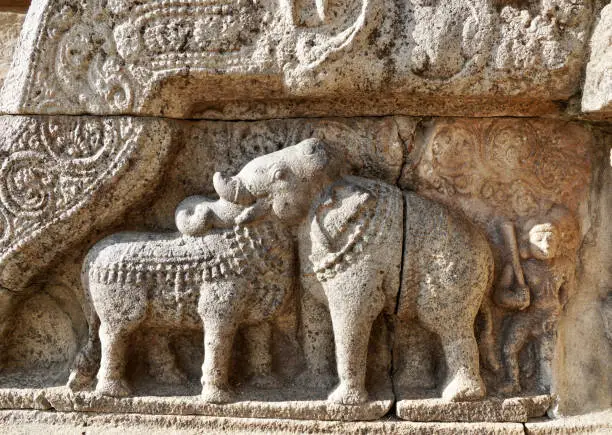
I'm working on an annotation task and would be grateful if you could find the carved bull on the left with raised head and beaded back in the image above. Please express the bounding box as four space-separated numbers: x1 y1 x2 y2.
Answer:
69 138 328 402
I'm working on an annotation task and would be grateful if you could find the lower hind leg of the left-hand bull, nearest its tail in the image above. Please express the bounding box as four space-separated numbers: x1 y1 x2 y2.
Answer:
96 323 131 397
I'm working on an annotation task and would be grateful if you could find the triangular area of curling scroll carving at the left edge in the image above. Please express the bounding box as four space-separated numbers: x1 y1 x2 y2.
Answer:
0 117 172 290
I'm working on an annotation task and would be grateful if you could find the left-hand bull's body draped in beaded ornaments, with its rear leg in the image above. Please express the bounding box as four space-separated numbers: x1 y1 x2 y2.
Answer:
75 221 294 396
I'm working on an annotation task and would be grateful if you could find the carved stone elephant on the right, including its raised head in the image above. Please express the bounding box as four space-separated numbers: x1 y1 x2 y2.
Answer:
216 139 493 404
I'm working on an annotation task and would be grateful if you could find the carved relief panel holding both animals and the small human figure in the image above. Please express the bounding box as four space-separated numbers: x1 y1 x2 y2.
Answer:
0 117 592 421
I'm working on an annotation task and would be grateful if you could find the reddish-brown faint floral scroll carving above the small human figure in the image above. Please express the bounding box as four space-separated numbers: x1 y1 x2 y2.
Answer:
418 120 590 218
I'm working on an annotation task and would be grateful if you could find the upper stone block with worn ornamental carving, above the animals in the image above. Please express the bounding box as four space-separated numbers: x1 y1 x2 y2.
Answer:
0 0 597 119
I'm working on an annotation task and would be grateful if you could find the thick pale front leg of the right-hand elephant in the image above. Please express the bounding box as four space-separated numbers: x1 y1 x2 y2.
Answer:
329 276 384 405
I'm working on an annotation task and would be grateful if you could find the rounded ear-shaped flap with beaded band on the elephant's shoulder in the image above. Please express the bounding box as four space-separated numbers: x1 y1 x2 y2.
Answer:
312 182 376 272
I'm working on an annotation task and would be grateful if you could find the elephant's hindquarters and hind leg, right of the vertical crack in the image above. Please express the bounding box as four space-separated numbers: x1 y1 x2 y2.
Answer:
396 192 494 401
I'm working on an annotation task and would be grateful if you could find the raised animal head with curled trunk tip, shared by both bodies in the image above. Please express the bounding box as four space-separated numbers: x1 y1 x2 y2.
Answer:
213 139 338 224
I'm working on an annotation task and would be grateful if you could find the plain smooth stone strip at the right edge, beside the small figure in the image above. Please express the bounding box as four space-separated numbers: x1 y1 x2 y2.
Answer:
551 130 612 415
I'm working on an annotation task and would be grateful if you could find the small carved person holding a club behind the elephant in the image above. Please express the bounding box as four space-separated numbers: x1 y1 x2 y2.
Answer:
494 206 578 393
